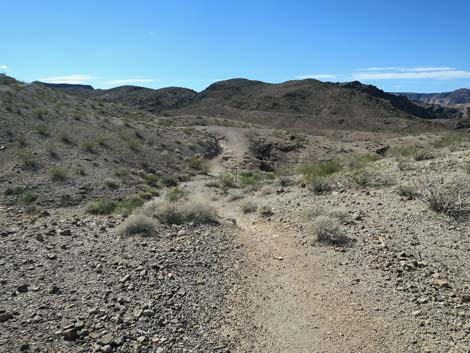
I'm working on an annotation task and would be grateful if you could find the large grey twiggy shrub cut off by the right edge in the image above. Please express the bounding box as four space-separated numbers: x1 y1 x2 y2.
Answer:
418 177 470 218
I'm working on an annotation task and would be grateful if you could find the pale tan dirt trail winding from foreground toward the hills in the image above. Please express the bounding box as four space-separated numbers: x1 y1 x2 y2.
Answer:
193 128 415 353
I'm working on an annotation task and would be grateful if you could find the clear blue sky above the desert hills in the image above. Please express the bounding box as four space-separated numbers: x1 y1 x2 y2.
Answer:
0 0 470 92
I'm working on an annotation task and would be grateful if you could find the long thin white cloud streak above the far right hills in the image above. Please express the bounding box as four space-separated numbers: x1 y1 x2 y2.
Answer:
352 69 470 81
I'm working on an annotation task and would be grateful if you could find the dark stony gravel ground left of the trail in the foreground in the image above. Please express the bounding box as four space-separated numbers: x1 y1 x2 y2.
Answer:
0 208 242 353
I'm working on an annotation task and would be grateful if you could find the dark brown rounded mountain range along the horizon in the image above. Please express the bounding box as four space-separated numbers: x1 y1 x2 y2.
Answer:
35 78 462 131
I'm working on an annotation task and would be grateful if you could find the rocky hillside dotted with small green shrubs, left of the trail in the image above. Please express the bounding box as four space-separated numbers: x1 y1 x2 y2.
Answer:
0 73 218 207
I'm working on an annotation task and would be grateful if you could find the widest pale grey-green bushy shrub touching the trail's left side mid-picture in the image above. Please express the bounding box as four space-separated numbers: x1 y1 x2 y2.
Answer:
142 198 218 224
